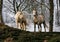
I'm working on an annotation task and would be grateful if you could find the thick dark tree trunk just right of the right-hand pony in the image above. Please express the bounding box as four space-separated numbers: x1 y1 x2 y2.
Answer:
49 0 54 32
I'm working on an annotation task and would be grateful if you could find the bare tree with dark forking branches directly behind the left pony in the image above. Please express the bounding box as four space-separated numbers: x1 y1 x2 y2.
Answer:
8 0 28 13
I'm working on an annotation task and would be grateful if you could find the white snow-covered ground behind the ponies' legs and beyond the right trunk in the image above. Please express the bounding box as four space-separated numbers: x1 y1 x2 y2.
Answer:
5 23 60 32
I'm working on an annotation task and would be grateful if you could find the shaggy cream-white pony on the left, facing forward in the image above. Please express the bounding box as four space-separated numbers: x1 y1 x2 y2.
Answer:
15 11 26 30
